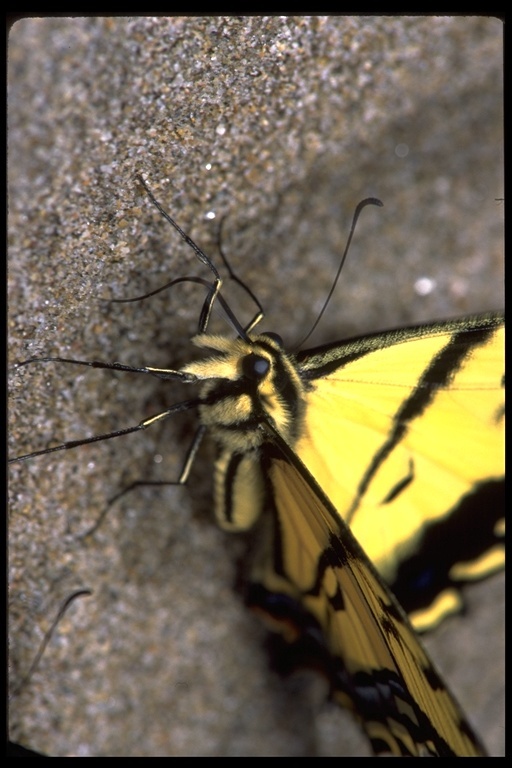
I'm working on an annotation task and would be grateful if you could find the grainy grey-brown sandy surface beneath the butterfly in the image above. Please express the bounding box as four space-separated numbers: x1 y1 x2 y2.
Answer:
8 16 504 756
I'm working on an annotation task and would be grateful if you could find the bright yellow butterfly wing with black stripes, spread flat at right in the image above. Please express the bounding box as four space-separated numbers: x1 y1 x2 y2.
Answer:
294 315 504 629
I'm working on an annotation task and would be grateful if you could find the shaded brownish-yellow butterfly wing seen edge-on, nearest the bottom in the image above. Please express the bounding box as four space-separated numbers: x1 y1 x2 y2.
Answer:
250 435 484 756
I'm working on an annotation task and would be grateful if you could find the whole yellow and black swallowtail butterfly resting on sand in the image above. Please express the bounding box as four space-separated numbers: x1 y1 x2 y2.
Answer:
9 178 504 756
